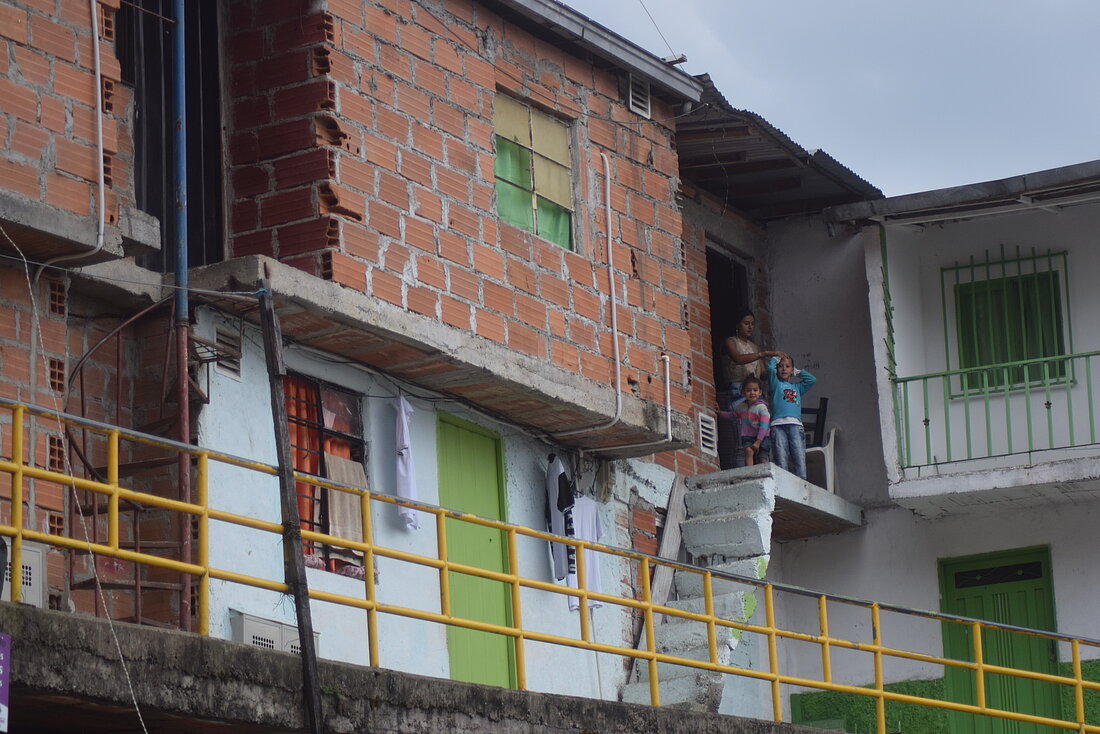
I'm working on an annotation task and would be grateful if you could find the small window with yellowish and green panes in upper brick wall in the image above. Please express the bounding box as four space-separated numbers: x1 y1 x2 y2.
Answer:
493 95 573 250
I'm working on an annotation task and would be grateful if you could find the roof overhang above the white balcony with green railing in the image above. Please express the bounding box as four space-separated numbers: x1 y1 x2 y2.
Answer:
822 161 1100 224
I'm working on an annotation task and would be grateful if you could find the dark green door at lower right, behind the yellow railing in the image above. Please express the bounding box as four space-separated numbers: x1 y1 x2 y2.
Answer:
939 548 1062 734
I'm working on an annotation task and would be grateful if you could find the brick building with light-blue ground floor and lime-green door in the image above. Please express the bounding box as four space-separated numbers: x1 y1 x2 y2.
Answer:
0 0 878 726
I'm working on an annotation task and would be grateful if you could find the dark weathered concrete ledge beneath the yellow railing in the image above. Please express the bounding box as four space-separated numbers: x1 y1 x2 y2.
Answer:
0 603 827 734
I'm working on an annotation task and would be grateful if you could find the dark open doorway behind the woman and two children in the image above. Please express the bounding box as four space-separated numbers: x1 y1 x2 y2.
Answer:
706 243 751 469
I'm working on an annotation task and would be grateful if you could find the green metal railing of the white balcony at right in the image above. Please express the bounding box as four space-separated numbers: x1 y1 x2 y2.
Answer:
893 352 1100 468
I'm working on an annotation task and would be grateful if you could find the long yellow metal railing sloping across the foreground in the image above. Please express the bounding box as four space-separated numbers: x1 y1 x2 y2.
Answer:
0 398 1100 734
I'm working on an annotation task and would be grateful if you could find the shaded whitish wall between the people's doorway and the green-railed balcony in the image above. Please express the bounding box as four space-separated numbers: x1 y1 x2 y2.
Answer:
768 219 887 504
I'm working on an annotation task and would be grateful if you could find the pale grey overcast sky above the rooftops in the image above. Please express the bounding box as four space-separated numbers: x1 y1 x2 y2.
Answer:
564 0 1100 196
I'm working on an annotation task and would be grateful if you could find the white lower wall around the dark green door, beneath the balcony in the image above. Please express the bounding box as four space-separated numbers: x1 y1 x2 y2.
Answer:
768 503 1100 693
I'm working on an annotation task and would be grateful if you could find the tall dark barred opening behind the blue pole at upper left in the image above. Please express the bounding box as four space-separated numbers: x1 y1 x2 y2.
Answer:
117 0 224 273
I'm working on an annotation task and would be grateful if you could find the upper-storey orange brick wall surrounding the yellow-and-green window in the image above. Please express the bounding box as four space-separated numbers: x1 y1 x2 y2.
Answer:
220 0 691 424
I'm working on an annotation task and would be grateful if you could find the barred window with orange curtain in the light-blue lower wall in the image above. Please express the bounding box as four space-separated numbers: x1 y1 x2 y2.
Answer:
283 375 365 571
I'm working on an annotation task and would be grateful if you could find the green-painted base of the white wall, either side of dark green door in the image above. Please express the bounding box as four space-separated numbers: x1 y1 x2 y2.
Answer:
791 660 1100 734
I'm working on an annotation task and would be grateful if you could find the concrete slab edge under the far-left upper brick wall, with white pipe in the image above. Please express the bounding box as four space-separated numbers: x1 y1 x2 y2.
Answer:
0 191 161 266
